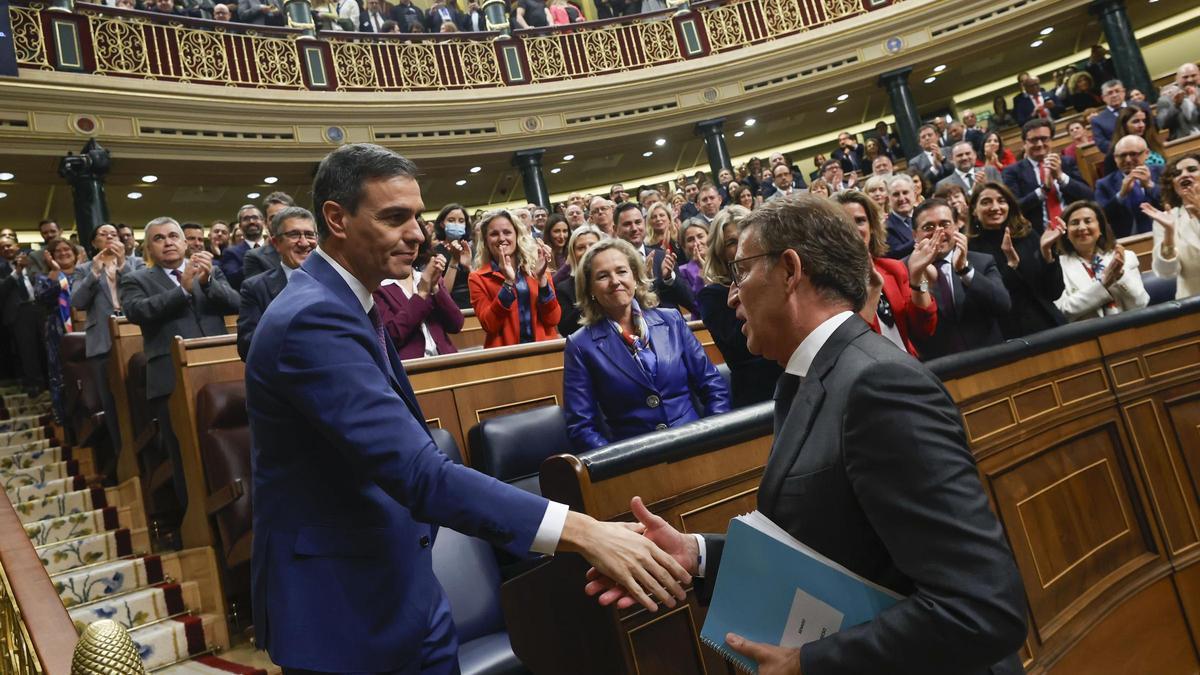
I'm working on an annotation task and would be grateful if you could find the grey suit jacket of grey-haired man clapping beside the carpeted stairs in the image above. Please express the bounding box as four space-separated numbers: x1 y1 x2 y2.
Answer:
118 265 238 399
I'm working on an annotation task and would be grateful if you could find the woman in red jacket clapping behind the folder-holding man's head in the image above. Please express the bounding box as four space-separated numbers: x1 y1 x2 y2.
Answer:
834 190 937 358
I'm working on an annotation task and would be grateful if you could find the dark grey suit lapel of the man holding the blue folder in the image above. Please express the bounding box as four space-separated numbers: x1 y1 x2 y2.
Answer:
758 315 870 513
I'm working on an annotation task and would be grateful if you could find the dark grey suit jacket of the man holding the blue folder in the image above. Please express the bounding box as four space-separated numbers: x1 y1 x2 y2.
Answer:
704 315 1026 675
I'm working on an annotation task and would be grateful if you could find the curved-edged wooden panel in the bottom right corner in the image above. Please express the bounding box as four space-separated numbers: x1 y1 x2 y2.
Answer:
1049 579 1200 675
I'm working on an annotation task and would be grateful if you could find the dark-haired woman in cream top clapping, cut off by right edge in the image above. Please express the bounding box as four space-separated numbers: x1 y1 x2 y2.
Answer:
1141 154 1200 300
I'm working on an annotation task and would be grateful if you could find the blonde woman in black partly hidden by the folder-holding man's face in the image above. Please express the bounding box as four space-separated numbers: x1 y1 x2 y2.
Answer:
696 207 784 408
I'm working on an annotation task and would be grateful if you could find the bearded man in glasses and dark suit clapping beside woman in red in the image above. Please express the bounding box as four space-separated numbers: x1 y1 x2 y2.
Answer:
913 198 1012 359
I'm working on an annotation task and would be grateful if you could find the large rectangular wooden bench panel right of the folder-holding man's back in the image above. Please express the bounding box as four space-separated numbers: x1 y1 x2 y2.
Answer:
990 414 1153 641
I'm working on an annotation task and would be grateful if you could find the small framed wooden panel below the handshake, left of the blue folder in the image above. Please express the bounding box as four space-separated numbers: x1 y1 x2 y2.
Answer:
625 604 706 675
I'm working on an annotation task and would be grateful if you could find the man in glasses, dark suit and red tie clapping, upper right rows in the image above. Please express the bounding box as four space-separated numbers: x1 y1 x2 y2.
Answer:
1003 119 1094 237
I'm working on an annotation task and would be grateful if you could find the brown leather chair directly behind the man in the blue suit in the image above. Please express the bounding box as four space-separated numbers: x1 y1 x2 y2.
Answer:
196 381 254 597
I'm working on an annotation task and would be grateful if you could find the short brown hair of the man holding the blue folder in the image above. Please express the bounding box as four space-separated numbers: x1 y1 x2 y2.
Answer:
742 195 871 311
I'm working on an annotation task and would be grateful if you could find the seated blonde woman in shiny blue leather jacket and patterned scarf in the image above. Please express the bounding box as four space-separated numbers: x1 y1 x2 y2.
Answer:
563 234 730 452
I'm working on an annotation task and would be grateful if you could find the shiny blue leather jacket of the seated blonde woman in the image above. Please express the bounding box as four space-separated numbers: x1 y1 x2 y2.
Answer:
563 309 730 452
